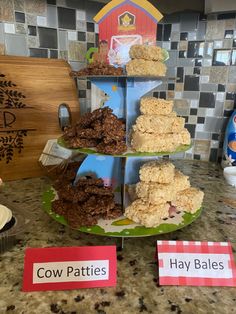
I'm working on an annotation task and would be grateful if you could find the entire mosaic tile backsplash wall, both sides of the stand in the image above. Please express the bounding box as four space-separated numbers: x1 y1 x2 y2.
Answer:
0 0 236 161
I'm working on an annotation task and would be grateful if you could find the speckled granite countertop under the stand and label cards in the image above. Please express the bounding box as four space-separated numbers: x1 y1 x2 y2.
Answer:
0 160 236 314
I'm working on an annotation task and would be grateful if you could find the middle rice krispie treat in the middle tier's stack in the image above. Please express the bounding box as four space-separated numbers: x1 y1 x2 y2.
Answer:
133 114 185 133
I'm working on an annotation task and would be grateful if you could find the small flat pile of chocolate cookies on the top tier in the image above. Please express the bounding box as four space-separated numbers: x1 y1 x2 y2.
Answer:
71 62 123 76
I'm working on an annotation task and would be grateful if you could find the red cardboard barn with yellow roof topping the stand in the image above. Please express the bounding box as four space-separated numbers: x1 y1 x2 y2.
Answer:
94 0 163 66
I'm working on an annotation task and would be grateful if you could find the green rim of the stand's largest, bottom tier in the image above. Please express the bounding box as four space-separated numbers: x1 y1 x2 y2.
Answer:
42 186 202 238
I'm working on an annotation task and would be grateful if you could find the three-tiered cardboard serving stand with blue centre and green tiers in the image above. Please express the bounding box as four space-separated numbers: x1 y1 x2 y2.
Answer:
43 75 201 243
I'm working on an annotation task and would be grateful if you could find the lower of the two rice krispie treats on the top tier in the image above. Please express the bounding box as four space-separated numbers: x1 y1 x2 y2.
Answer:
126 59 166 76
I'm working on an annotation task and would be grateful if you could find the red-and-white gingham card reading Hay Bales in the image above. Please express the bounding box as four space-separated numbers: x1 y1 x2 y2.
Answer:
157 241 236 286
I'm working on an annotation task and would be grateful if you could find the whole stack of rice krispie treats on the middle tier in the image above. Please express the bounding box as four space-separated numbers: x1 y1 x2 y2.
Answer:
131 97 191 152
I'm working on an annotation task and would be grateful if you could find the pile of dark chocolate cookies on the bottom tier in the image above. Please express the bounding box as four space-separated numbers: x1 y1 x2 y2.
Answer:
52 170 122 228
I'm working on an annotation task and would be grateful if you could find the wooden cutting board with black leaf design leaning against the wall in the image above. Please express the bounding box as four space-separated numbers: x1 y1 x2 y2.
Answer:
0 56 79 181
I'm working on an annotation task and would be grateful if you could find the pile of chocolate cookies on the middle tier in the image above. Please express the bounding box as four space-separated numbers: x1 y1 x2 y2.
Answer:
63 107 126 155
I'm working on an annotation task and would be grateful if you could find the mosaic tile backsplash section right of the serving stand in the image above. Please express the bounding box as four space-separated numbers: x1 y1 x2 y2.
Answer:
154 13 236 161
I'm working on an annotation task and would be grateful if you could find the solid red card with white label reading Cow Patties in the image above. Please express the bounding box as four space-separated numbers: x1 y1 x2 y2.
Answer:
22 246 116 291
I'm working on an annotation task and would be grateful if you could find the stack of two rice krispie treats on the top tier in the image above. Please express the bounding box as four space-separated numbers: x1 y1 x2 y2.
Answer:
126 45 166 76
